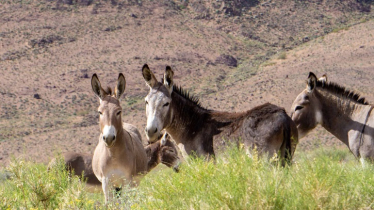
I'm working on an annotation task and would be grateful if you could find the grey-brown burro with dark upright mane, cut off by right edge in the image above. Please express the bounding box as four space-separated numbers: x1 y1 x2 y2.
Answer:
291 72 374 164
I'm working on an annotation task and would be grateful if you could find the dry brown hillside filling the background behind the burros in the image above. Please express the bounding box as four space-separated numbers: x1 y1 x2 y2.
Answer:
0 0 374 166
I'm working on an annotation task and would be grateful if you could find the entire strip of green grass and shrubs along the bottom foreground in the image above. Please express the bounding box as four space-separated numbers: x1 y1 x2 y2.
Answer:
0 149 374 209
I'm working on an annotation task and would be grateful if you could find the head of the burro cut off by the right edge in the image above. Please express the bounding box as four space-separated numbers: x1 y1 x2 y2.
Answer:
291 72 327 138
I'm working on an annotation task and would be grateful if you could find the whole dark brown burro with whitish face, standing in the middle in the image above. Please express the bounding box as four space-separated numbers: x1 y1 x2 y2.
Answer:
142 64 298 164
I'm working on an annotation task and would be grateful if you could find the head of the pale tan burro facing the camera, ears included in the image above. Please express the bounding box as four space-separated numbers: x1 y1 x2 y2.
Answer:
91 73 126 148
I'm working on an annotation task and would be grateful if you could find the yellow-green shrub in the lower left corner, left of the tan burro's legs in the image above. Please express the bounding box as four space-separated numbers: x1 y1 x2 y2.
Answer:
0 158 93 209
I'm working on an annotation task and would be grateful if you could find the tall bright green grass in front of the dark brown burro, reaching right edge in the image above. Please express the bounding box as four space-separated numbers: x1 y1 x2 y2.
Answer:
138 149 374 209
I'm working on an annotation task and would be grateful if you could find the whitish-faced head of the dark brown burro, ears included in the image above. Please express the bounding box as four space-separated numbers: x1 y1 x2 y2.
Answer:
142 64 174 142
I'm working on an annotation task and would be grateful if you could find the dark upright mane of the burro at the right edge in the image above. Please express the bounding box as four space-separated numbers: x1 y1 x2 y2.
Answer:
317 81 369 105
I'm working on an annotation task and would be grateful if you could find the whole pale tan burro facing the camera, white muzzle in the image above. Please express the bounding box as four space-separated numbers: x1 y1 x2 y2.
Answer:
91 74 148 202
